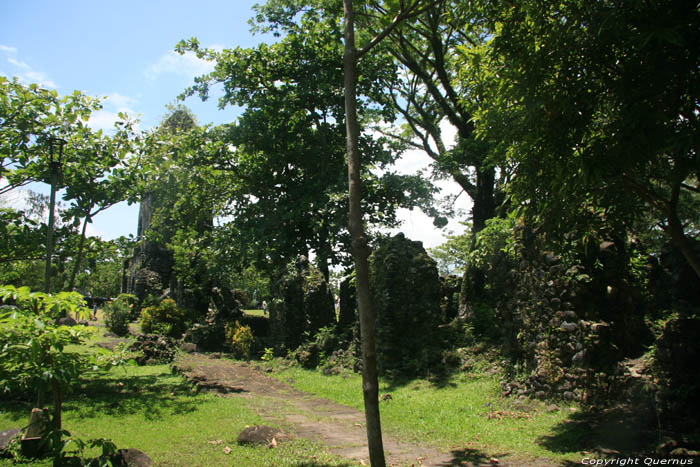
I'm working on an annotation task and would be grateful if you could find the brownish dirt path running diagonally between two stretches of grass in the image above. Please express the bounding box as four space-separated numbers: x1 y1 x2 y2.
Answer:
174 353 550 466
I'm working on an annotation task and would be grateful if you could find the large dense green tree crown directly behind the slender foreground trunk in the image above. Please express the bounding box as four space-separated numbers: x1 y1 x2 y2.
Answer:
178 18 432 278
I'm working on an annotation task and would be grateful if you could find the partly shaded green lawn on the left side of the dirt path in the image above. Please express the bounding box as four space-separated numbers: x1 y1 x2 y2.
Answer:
0 344 350 467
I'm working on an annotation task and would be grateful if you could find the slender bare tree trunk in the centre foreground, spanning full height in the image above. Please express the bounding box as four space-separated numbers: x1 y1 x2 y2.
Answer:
343 0 386 467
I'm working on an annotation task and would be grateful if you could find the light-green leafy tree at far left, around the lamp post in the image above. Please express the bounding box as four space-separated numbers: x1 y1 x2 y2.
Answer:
0 77 138 289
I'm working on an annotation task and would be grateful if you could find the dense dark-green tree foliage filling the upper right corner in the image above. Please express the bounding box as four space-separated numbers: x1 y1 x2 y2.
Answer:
472 0 700 277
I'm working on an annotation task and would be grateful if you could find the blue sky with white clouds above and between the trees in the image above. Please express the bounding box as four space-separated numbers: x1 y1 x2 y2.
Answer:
0 0 466 246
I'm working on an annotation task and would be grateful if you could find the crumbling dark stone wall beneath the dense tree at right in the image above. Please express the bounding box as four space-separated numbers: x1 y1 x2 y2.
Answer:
497 226 651 401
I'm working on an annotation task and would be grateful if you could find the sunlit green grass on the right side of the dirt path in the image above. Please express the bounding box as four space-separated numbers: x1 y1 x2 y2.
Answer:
266 360 581 461
